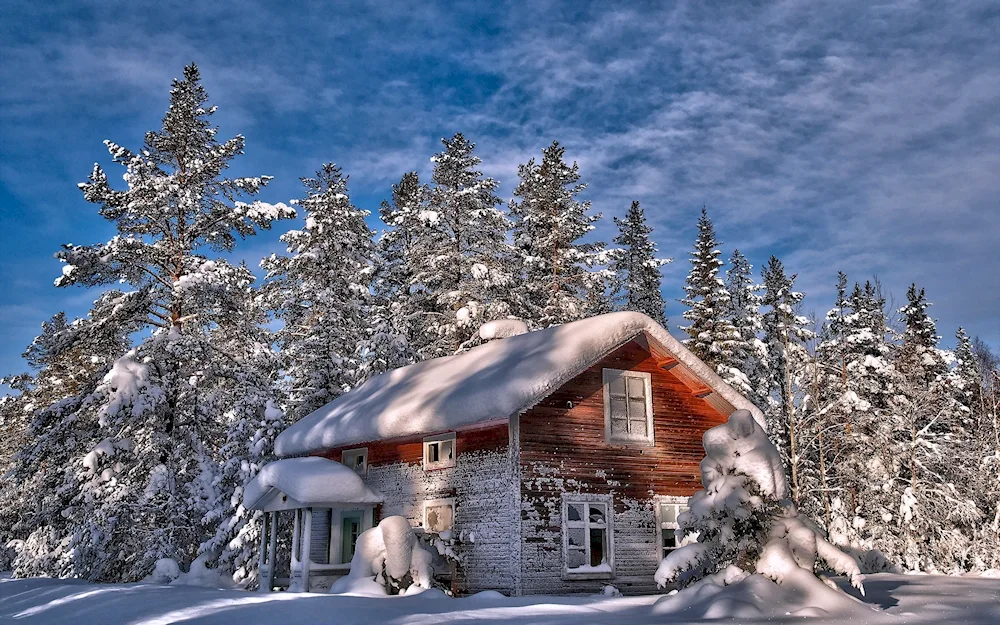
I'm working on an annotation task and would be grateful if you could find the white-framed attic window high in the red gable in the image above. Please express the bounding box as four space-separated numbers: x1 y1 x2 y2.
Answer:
604 369 653 445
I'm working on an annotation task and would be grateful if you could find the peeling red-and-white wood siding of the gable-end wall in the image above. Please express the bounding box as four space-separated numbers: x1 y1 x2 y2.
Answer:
519 342 728 594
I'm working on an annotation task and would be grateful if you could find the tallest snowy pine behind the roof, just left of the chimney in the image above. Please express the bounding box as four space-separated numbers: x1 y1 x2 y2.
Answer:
410 133 514 359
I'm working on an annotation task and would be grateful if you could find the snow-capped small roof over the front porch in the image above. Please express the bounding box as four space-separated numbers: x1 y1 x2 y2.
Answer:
243 456 382 510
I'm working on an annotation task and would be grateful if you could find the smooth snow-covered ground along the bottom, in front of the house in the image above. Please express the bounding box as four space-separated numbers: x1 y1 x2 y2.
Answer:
0 574 1000 625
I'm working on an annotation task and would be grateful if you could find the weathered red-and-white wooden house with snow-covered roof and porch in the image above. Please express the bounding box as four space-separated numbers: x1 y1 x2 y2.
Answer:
248 312 764 595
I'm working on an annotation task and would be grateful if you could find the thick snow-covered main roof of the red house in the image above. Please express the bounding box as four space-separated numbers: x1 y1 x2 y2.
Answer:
275 312 764 456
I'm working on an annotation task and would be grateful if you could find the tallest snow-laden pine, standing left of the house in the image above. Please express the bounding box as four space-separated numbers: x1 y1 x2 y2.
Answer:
49 65 294 581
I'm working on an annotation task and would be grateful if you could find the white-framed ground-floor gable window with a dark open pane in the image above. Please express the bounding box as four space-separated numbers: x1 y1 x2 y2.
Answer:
563 493 614 578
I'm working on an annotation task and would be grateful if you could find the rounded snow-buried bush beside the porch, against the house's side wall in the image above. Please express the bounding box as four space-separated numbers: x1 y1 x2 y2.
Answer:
330 516 434 595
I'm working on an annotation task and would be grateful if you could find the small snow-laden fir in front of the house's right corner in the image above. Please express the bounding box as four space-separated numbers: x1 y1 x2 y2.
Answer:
655 410 864 618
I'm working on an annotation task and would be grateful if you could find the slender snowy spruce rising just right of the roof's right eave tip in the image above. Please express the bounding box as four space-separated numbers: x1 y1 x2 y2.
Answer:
761 256 815 502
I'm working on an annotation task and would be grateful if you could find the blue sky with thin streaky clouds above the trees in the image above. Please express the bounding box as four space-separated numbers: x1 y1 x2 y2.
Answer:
0 0 1000 373
